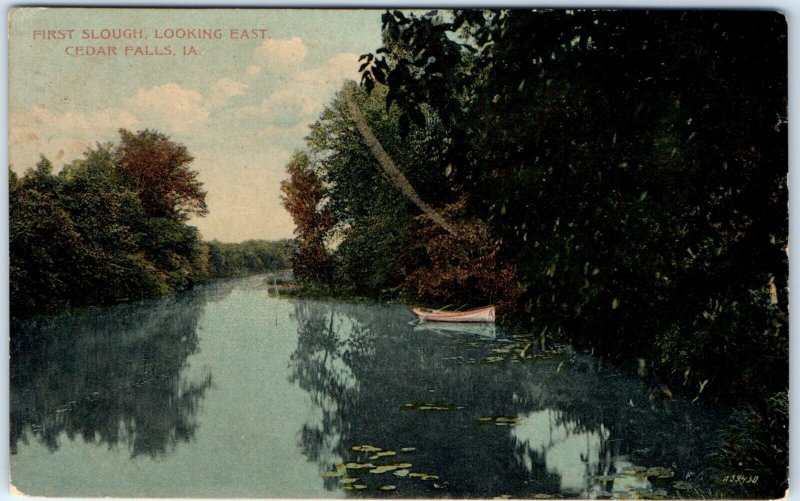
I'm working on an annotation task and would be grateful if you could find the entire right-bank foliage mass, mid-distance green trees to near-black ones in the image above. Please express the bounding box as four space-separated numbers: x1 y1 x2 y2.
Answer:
286 10 788 494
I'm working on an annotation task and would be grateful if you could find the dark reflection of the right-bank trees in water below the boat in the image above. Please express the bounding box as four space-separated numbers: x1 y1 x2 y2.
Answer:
289 301 715 497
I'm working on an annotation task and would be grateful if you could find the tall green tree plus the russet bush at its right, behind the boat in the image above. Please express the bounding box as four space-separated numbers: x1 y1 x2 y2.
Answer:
290 79 515 304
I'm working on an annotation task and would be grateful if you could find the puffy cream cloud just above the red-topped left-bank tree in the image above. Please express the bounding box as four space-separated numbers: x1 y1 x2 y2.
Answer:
125 82 210 134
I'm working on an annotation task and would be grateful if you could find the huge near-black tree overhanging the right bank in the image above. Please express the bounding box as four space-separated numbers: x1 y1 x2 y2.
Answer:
362 10 788 406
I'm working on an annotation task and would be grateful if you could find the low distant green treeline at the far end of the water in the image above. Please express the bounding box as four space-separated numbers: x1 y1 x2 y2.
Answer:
205 239 294 278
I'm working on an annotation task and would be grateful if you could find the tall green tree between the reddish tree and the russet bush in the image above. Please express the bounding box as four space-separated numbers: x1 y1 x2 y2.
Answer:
292 83 452 297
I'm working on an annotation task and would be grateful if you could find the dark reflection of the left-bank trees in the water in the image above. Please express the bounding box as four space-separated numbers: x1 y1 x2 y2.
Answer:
10 282 232 457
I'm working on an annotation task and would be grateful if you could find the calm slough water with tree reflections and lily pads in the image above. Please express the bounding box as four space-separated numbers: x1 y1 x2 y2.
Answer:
10 277 721 498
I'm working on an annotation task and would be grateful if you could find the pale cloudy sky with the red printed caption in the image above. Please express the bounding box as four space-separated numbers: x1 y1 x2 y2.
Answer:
8 8 382 242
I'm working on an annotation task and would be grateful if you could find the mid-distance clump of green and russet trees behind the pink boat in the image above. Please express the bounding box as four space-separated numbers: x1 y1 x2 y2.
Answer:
283 83 513 304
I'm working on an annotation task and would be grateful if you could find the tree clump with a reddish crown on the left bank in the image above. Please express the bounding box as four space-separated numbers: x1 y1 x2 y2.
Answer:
9 130 209 316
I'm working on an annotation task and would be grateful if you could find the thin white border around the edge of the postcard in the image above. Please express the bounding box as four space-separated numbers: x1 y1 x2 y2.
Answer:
0 0 800 500
